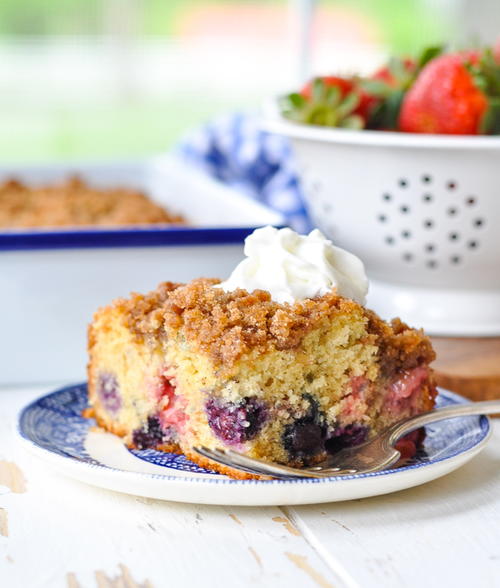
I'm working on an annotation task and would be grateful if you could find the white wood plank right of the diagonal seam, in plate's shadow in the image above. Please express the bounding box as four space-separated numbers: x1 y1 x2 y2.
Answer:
286 421 500 588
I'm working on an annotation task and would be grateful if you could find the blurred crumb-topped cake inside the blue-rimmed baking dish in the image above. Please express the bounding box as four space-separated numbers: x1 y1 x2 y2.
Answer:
0 177 185 228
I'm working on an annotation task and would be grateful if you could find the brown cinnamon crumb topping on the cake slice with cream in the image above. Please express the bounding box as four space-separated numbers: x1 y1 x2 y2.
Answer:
104 278 435 373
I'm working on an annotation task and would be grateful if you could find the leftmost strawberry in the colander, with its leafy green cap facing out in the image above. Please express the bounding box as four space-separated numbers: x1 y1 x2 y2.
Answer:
282 76 375 129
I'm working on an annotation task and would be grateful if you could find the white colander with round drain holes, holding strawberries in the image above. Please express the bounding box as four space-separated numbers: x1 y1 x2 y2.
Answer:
265 108 500 336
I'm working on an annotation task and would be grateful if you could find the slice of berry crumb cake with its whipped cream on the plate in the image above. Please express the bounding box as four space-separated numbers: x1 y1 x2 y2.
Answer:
89 227 436 478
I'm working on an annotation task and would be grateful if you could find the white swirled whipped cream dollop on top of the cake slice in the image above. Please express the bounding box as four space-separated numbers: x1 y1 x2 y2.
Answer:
219 226 368 304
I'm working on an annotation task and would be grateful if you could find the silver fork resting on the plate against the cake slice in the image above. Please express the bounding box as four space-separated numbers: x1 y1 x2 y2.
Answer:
193 400 500 478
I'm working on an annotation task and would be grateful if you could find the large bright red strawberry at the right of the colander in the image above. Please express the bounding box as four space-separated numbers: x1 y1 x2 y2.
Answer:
399 54 488 135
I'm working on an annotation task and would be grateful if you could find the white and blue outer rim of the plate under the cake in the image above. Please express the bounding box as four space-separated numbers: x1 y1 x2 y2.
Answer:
16 382 492 487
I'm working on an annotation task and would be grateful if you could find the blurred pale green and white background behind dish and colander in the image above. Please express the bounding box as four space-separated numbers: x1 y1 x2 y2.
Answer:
0 0 453 162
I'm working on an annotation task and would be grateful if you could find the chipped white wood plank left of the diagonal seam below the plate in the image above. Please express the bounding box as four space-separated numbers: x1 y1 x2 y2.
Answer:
0 390 342 588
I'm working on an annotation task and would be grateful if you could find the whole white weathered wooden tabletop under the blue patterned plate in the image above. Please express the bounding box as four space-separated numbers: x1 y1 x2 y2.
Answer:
0 387 500 588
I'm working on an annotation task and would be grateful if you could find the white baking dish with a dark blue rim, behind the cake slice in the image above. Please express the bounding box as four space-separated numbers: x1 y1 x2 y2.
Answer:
0 157 283 384
